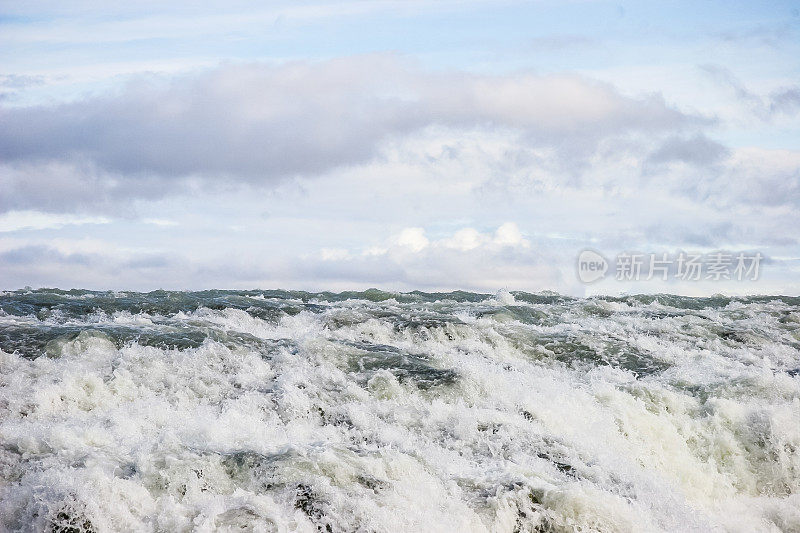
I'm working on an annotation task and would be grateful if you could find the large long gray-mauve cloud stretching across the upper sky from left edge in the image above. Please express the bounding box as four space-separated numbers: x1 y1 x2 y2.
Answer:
0 56 703 211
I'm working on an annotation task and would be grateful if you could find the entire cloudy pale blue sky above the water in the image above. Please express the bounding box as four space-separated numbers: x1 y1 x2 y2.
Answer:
0 0 800 296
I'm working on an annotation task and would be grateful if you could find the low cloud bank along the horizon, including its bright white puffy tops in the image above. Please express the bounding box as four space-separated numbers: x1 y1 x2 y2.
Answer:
0 222 564 292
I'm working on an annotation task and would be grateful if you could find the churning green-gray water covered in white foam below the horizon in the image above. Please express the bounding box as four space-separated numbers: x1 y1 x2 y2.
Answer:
0 290 800 533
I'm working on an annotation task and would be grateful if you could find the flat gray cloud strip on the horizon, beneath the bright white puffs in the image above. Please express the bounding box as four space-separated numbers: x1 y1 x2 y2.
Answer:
0 236 563 292
